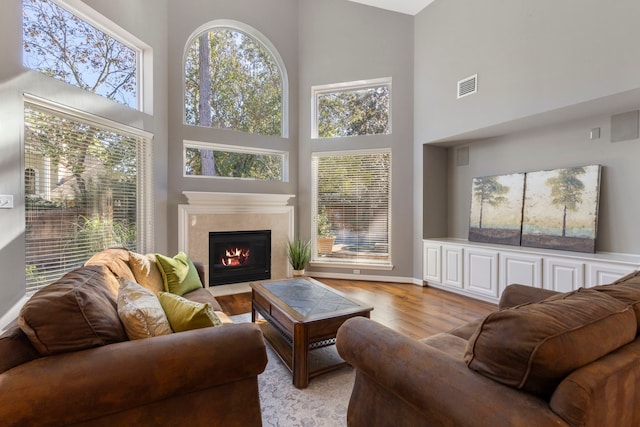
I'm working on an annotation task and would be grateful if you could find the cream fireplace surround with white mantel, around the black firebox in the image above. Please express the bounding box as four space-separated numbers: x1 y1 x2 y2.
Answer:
178 191 295 286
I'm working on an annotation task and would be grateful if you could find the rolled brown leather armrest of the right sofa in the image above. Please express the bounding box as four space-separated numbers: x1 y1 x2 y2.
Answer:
337 317 566 426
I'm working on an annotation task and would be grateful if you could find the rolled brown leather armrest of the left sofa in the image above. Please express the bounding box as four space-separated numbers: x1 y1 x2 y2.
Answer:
0 323 267 426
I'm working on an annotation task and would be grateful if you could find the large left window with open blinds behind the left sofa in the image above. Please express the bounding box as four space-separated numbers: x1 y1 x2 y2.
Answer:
24 98 152 289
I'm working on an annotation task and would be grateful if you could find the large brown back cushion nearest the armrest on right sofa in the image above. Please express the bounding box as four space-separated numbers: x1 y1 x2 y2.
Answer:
464 289 636 397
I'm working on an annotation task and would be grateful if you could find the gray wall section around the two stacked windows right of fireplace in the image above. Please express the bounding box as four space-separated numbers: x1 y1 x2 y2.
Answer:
298 0 413 279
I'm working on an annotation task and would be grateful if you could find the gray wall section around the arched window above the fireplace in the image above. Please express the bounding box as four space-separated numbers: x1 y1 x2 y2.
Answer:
167 0 298 253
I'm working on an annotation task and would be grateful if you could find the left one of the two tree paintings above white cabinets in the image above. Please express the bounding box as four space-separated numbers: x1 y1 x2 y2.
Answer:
469 173 525 246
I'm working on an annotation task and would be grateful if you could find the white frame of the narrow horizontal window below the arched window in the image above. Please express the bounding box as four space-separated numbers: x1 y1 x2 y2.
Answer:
182 140 289 182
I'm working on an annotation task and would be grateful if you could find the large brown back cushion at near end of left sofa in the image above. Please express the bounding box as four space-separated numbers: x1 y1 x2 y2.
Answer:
18 265 127 355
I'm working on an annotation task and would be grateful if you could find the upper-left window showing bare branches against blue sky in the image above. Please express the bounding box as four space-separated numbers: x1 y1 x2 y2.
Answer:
22 0 140 108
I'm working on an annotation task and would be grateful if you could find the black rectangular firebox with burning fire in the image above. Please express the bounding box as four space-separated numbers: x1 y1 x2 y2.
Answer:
209 230 271 286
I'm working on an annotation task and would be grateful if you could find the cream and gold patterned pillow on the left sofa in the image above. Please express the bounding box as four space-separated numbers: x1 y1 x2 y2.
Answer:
118 279 172 340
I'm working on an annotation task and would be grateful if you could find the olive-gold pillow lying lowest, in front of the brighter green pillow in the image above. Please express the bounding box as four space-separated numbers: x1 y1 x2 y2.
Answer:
158 292 222 332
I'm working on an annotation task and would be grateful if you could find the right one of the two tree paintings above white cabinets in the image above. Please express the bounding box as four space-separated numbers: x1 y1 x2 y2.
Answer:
522 165 600 253
